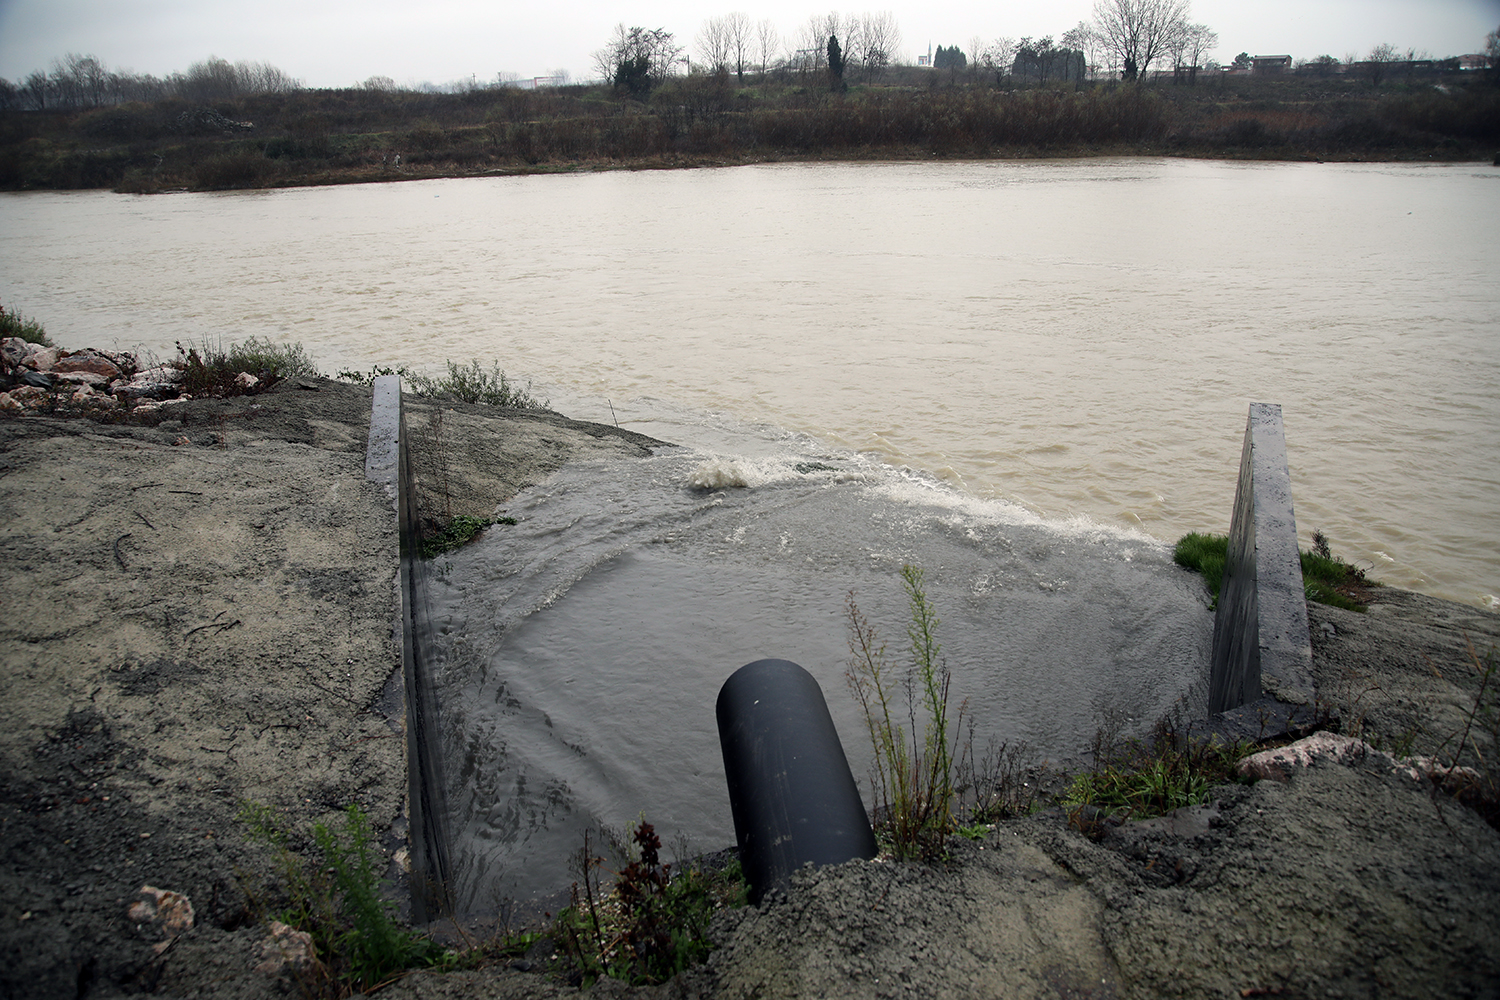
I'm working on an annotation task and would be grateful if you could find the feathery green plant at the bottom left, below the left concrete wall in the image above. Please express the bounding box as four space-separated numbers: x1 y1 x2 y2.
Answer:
240 802 447 997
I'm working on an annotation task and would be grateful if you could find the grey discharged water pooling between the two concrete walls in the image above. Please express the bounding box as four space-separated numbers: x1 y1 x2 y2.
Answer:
431 410 1212 913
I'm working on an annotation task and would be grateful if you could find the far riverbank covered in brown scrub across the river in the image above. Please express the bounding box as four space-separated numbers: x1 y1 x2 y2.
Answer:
0 72 1500 192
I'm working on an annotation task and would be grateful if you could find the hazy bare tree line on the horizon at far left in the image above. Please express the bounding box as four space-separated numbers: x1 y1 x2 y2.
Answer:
0 52 302 111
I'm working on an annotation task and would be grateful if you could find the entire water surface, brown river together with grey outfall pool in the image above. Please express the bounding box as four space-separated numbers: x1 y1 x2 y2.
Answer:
0 159 1500 907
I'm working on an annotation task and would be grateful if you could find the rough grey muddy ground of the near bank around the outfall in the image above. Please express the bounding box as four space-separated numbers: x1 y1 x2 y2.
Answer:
0 379 1500 997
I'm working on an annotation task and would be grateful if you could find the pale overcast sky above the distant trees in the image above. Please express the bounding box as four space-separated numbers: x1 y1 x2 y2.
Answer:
0 0 1500 87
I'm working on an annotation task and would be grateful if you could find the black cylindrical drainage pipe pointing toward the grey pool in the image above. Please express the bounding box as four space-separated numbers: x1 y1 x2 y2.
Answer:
716 660 878 903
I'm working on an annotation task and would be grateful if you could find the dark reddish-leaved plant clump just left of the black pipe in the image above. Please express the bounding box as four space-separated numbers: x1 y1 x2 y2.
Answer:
554 820 746 984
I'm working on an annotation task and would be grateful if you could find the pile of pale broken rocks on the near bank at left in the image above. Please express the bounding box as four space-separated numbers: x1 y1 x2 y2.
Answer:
0 337 235 415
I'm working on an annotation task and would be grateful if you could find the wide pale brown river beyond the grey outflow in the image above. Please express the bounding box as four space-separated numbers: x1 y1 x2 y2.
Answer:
0 159 1500 607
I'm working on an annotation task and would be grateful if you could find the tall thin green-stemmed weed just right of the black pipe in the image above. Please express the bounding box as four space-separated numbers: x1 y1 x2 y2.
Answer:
845 565 968 859
